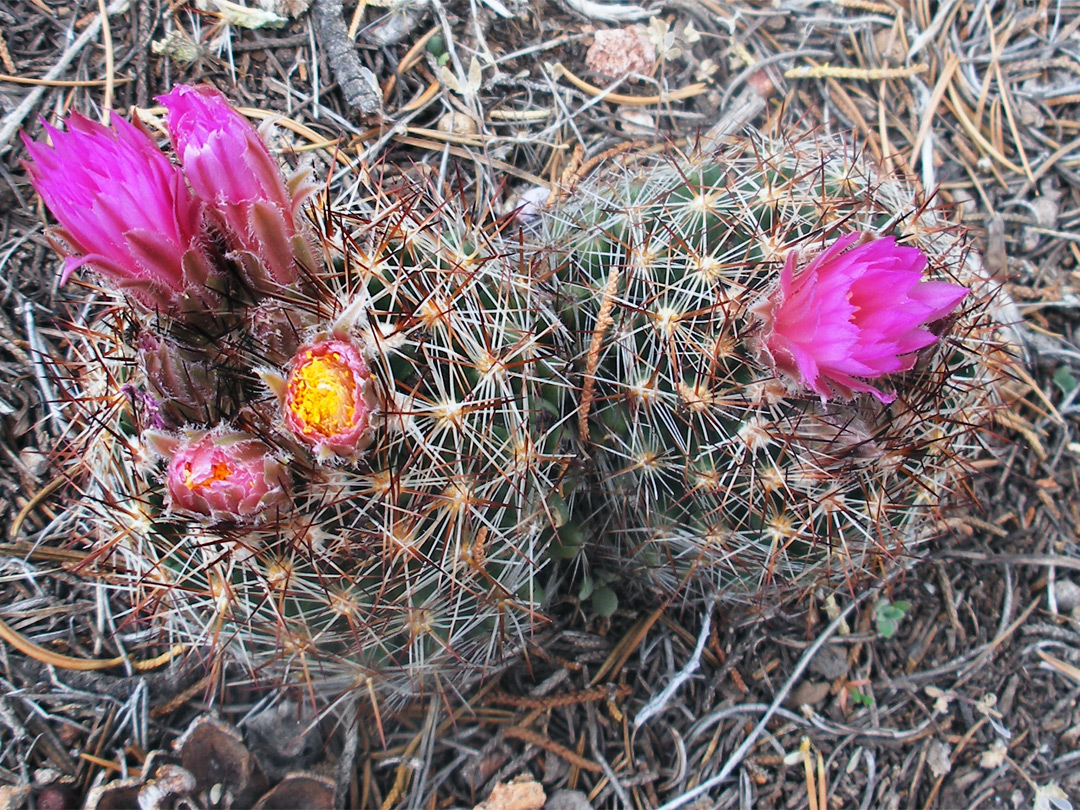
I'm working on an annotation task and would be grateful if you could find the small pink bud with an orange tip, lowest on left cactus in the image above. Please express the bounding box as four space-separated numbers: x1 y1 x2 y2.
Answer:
165 433 288 523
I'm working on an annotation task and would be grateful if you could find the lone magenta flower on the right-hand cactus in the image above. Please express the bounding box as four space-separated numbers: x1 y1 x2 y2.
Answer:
755 233 969 403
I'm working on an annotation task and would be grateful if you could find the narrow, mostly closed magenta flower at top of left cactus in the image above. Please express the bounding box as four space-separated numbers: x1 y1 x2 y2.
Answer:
158 84 305 285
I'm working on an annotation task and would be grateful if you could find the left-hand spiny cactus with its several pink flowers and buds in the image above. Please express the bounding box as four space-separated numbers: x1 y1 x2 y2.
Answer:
28 89 569 702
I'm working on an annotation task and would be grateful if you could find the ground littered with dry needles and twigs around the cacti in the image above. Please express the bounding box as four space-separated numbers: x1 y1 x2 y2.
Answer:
0 0 1080 810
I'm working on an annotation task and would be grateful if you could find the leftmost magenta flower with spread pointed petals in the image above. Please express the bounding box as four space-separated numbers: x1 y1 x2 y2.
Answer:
23 113 208 308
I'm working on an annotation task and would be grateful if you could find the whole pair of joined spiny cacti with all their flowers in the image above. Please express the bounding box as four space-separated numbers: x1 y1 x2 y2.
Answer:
19 86 1007 699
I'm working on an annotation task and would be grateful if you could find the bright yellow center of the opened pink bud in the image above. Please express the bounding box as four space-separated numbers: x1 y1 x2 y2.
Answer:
288 351 356 436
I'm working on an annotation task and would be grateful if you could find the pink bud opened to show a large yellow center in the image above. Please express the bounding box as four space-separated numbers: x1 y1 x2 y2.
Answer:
284 340 375 459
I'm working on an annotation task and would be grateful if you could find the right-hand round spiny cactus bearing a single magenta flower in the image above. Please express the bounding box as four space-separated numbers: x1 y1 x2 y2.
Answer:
536 135 1009 600
